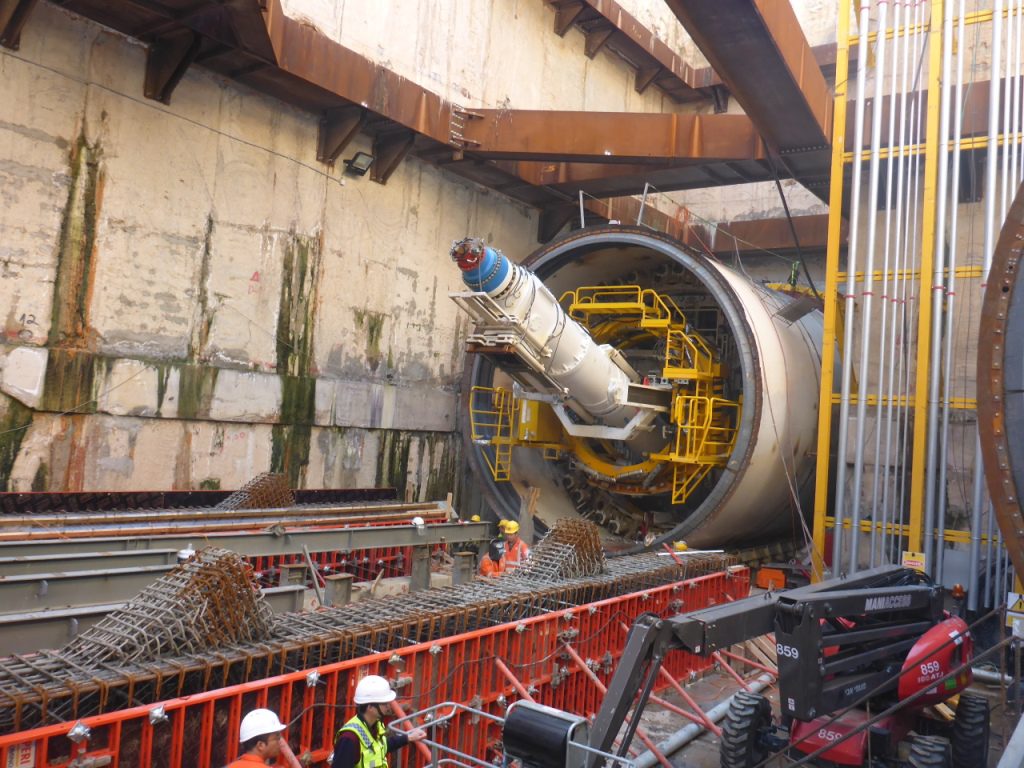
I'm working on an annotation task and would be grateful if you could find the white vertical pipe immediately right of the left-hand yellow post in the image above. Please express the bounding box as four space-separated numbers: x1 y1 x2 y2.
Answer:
833 0 872 575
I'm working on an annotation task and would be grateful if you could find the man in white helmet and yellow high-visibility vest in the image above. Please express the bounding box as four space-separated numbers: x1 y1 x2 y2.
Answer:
331 675 427 768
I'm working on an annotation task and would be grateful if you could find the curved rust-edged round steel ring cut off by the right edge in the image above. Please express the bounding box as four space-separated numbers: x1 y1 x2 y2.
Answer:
978 185 1024 581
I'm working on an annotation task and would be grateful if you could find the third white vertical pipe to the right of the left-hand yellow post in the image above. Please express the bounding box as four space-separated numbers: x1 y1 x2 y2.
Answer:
870 0 905 568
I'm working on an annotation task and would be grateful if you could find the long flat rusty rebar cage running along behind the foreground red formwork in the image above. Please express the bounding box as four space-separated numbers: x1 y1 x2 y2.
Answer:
0 553 729 733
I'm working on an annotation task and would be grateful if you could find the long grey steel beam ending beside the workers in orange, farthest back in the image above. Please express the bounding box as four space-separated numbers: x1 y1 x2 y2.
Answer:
0 522 494 557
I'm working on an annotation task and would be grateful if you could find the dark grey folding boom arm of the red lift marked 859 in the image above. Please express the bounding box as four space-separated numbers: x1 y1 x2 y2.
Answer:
585 565 942 768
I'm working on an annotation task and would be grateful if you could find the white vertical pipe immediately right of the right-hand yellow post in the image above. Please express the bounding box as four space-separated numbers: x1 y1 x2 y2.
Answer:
922 2 953 578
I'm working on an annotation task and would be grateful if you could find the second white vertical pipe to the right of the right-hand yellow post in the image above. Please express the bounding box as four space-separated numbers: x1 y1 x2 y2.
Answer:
935 0 966 589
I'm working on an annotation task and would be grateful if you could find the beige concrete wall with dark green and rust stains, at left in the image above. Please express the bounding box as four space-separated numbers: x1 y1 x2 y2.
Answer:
8 0 831 499
